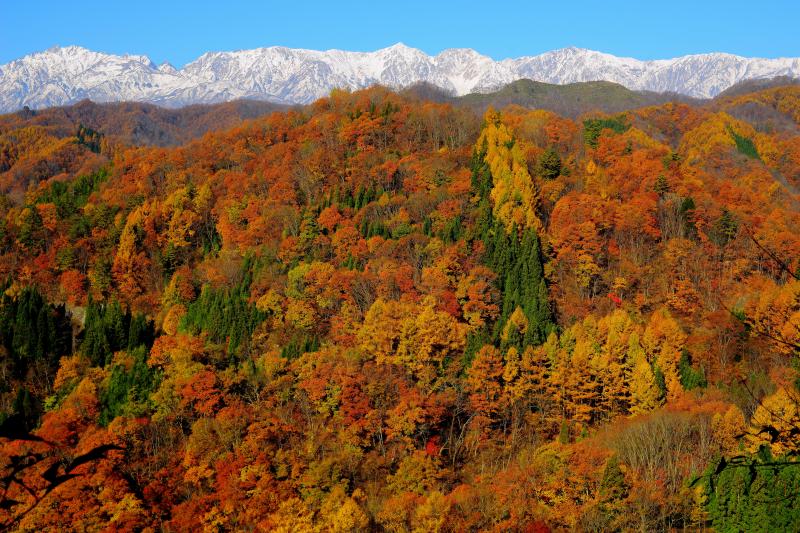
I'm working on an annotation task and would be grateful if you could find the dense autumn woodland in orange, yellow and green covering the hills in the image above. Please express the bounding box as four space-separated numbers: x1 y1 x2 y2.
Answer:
0 81 800 532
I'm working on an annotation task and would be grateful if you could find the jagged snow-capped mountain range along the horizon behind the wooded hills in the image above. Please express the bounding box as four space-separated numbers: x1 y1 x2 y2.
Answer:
0 44 800 112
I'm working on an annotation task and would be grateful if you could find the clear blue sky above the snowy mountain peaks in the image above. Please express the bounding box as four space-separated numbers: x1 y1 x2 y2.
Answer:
0 0 800 67
